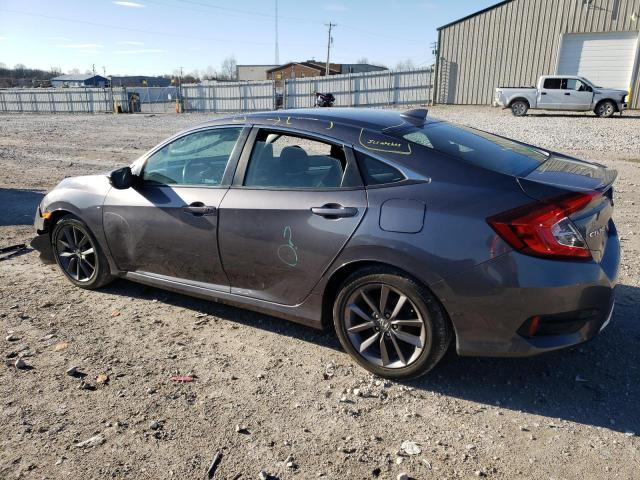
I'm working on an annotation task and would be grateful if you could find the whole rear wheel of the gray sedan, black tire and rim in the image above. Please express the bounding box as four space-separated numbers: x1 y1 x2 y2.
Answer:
333 267 453 380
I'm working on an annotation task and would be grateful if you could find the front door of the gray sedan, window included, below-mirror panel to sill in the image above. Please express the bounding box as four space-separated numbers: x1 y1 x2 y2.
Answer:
103 126 248 291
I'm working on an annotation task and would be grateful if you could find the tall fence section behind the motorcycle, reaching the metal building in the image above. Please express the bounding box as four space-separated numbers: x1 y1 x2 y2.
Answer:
284 69 435 108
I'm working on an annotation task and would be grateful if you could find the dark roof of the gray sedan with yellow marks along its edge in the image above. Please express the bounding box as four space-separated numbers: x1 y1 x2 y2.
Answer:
200 108 438 135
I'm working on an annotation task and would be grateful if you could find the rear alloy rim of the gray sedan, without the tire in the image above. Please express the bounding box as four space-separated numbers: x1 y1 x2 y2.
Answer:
344 283 428 368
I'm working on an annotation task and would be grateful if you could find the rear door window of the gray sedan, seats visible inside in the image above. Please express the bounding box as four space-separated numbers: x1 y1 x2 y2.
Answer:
244 130 346 189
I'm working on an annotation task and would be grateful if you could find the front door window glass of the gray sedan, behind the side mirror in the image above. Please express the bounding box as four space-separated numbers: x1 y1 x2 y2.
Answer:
142 127 242 186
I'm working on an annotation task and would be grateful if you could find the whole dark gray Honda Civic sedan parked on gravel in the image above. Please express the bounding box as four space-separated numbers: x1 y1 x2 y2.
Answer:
33 109 620 379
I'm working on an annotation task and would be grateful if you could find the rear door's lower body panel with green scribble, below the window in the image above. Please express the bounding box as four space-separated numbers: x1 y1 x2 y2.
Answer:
219 188 367 305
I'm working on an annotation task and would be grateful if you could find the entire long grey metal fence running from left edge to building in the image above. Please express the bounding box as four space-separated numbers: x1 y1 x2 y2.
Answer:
0 69 434 113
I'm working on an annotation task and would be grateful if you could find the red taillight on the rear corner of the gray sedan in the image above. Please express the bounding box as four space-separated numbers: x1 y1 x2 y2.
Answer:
487 192 600 259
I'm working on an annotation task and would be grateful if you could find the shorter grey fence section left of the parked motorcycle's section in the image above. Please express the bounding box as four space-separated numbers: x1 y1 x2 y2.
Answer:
182 80 276 112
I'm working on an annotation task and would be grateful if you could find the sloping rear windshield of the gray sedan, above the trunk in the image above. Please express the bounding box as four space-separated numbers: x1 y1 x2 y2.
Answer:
400 122 548 176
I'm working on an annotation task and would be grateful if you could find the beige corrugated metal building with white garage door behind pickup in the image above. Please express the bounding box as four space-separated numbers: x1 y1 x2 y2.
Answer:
435 0 640 108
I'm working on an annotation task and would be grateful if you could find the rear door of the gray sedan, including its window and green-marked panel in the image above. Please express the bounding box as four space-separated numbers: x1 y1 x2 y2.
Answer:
219 127 367 305
